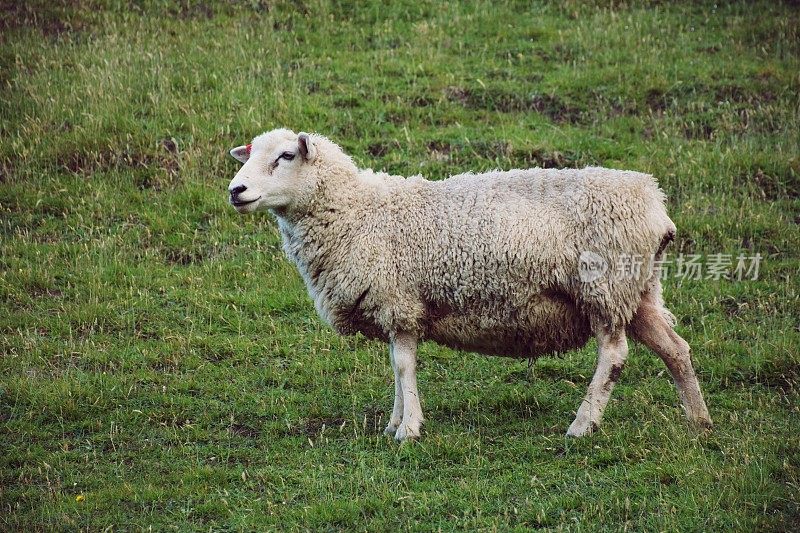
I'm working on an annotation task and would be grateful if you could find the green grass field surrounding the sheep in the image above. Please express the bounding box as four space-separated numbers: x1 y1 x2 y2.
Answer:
0 0 800 531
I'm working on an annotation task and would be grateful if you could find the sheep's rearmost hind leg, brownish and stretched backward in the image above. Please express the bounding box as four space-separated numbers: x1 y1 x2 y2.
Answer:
629 293 712 428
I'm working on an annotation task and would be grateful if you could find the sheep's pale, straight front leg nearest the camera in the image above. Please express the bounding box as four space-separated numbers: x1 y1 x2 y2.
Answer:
387 333 423 441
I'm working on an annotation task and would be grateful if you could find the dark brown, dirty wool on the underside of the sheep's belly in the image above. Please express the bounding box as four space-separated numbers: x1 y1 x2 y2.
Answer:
425 295 591 357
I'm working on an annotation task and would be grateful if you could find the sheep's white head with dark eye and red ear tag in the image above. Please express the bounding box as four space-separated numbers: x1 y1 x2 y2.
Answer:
228 129 318 213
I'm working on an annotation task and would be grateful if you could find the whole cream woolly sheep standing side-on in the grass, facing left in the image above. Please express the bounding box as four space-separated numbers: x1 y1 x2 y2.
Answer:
229 129 711 441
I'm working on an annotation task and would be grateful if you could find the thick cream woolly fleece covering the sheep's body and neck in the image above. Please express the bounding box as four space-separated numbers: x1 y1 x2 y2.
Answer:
245 130 675 357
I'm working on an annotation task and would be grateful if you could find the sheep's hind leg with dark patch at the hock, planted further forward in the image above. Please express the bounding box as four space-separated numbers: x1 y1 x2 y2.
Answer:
567 329 628 437
